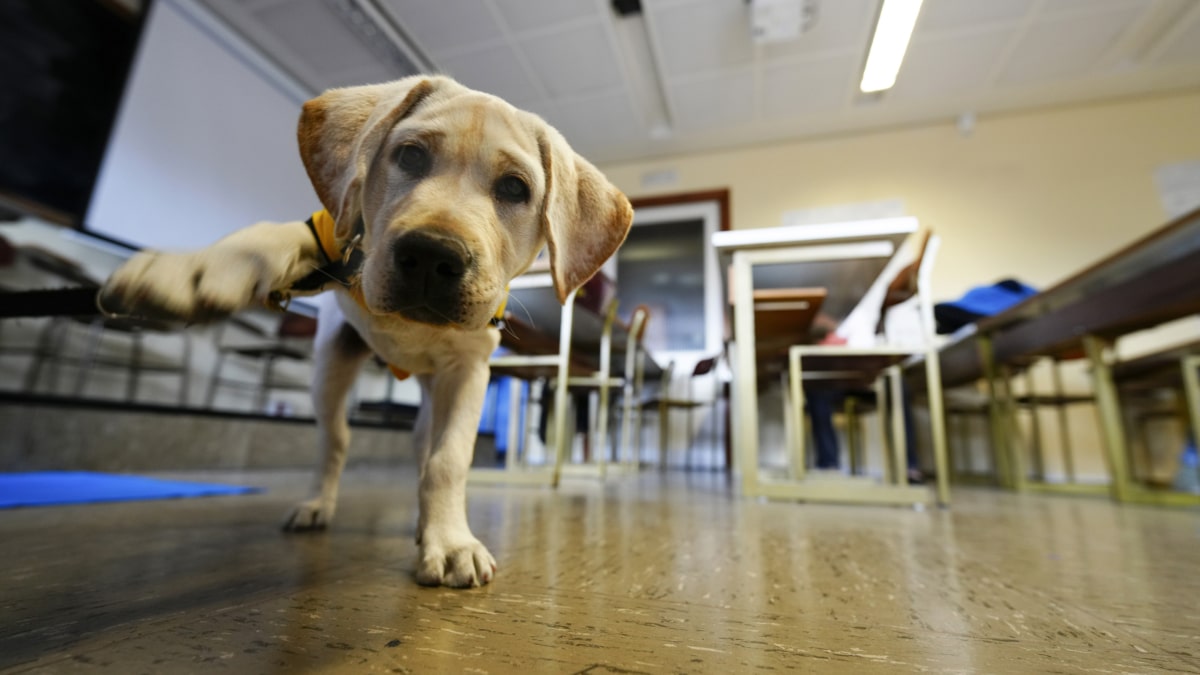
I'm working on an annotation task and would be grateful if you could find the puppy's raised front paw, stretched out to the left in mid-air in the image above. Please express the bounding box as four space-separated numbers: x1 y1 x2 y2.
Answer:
100 249 270 321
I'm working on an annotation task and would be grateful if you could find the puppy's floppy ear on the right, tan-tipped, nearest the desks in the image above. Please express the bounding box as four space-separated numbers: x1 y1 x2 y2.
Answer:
538 126 634 304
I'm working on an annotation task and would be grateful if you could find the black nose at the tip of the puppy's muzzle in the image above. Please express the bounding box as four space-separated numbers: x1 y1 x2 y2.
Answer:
391 232 474 325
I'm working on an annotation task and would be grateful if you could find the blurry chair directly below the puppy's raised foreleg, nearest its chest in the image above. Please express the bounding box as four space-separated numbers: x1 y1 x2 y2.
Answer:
204 312 317 412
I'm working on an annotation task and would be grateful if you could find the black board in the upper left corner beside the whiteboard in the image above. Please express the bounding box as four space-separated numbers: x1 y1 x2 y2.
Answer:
0 0 150 227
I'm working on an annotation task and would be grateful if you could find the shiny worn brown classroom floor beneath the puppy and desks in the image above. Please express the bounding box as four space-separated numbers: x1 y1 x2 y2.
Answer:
0 471 1200 674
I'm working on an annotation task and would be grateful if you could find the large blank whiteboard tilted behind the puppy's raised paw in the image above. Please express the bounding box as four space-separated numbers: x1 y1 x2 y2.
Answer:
84 0 319 250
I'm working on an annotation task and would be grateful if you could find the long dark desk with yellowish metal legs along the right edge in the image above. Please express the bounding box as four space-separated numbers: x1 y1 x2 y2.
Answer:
912 210 1200 503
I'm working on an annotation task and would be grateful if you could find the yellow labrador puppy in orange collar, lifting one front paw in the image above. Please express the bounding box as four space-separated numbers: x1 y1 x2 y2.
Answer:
100 76 632 587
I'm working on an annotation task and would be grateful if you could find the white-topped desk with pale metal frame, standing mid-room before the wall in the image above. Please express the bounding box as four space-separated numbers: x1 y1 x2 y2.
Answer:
713 217 936 501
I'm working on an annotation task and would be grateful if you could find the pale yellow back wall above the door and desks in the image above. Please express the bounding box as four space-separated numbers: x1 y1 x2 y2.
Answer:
602 92 1200 299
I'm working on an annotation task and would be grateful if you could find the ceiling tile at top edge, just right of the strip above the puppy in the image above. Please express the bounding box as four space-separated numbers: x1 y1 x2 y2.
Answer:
380 0 503 59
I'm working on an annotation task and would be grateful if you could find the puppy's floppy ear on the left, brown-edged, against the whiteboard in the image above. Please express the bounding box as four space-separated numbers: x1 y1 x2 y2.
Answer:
296 76 449 240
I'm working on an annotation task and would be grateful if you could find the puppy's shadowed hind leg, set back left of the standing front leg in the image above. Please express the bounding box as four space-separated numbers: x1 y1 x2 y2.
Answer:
283 298 371 532
